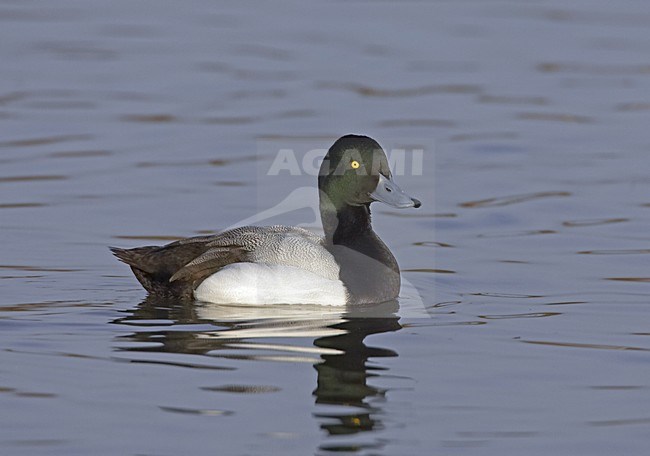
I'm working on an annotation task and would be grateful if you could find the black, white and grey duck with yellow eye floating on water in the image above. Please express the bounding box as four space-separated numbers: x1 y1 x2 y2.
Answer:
110 135 421 306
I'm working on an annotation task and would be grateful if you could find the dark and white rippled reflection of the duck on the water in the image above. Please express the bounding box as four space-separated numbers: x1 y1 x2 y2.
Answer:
114 296 401 435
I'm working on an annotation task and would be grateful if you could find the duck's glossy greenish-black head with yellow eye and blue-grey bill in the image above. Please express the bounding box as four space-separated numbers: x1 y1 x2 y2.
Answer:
318 135 420 208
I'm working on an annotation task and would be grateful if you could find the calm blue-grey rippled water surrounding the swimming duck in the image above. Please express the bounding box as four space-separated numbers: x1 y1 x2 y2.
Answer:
0 0 650 455
